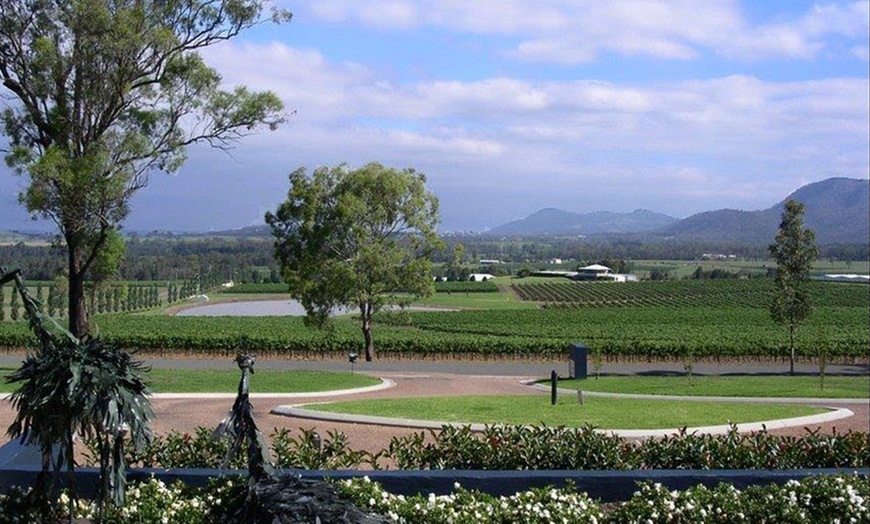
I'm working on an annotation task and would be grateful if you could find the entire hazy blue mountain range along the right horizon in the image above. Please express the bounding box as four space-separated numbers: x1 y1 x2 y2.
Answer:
486 178 870 245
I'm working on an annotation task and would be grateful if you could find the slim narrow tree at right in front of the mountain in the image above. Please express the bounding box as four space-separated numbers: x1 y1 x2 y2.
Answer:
768 200 819 375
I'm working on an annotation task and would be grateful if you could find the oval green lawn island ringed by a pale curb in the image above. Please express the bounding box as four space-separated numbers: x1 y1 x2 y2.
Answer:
306 395 825 429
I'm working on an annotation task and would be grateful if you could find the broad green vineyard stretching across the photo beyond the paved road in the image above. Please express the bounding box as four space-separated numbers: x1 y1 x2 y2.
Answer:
0 280 870 362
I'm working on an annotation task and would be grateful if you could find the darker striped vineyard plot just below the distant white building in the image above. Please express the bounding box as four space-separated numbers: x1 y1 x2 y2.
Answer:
511 279 870 308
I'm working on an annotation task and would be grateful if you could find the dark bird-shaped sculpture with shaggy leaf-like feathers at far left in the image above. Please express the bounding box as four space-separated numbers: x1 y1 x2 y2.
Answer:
0 268 153 516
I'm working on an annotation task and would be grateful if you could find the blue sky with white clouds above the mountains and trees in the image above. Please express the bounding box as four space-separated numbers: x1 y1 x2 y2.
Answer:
0 0 870 232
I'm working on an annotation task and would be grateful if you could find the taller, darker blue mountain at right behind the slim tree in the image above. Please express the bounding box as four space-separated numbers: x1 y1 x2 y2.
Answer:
659 178 870 245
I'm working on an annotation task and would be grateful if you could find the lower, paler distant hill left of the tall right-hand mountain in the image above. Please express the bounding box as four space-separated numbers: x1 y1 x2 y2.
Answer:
486 208 677 236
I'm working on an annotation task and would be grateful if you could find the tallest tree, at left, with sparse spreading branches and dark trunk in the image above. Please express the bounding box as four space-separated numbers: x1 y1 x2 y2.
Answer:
0 0 286 337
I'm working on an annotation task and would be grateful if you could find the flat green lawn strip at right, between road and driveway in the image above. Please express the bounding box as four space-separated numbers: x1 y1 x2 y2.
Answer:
560 375 870 398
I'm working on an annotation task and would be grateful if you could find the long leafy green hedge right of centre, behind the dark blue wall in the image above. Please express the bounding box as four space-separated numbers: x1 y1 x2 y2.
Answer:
387 426 870 470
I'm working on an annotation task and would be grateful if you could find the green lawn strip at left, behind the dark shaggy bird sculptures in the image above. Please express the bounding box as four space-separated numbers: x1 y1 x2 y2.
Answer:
0 367 380 393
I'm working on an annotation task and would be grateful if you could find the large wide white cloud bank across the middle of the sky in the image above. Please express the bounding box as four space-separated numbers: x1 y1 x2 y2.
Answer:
201 37 870 217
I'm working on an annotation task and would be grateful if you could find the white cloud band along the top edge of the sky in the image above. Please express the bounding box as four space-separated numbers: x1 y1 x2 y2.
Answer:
303 0 870 64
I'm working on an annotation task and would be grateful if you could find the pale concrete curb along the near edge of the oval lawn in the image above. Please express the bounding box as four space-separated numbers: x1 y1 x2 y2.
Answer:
272 404 854 438
